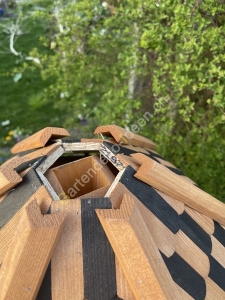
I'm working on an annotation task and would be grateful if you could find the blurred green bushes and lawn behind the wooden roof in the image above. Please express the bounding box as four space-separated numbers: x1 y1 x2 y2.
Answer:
0 0 225 201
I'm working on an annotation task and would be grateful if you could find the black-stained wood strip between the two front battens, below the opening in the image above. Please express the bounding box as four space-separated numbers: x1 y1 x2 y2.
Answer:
81 198 117 300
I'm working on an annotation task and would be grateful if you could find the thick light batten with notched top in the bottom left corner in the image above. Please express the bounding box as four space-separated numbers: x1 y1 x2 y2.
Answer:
0 201 65 300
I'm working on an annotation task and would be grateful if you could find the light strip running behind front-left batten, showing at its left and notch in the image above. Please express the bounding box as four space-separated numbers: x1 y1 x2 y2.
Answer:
0 186 52 264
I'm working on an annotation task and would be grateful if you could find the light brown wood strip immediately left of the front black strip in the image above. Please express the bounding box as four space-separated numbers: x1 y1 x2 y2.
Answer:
51 199 84 300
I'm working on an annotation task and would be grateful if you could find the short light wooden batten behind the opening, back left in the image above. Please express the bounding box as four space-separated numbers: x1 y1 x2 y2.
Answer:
11 127 69 154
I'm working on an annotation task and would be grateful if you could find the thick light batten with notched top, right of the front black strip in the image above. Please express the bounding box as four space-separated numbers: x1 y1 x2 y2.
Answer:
96 196 181 300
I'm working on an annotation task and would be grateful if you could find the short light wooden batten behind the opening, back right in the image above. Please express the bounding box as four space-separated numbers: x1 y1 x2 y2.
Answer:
94 125 156 149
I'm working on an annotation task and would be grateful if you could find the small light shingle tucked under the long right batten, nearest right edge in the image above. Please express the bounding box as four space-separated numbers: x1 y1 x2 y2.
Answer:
185 206 214 234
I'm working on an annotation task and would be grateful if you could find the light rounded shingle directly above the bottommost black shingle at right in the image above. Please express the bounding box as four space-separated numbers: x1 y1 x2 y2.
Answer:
176 230 210 278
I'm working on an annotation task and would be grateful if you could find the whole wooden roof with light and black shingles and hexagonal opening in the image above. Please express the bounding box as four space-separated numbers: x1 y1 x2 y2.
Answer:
0 125 225 300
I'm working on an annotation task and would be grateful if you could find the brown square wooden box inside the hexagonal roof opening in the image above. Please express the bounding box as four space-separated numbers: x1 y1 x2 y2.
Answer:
52 155 115 199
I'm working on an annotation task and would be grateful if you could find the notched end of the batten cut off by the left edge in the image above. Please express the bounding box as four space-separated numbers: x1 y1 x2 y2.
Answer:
0 157 26 196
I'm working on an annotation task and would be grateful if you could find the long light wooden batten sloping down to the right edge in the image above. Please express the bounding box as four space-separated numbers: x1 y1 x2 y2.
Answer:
132 153 225 225
